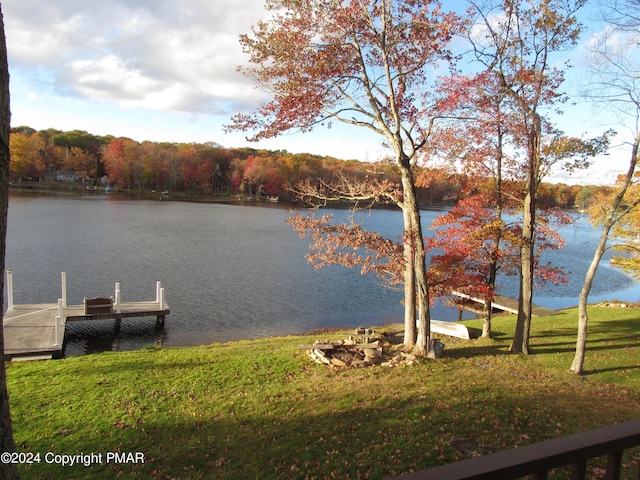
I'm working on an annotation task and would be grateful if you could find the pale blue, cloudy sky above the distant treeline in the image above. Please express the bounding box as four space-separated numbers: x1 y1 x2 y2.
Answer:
2 0 628 184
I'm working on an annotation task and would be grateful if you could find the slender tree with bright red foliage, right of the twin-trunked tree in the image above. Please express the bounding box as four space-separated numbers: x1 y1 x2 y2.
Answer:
433 46 608 342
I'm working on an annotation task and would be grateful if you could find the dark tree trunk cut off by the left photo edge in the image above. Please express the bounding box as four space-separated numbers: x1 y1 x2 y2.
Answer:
0 7 20 480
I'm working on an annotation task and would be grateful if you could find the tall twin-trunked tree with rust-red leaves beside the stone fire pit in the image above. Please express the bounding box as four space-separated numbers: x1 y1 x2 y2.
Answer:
228 0 461 354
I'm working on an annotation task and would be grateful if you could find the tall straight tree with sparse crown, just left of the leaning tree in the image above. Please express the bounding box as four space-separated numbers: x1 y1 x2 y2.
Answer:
468 0 586 353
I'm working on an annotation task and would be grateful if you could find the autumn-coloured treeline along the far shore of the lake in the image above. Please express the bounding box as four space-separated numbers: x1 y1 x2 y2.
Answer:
10 126 608 209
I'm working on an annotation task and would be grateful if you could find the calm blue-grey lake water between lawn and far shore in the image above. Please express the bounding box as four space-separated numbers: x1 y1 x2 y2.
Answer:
4 195 640 356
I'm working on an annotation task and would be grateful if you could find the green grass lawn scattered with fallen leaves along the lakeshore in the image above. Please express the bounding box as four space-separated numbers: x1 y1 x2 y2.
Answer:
7 307 640 479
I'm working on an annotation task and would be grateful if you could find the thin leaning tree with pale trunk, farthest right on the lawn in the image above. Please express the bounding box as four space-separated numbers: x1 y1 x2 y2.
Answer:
571 0 640 374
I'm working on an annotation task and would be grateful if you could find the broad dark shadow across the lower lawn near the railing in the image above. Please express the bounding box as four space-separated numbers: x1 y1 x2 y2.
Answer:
13 373 632 479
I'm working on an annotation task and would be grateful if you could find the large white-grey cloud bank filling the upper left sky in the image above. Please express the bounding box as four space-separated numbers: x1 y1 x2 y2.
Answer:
3 0 264 114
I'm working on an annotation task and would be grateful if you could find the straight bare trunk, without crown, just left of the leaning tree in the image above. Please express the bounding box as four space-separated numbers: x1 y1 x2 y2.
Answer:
509 113 542 354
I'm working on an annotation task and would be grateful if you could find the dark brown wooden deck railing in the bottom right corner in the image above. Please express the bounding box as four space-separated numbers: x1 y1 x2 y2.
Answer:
392 419 640 480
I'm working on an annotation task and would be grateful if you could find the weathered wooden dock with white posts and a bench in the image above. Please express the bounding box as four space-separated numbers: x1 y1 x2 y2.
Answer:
3 270 169 360
